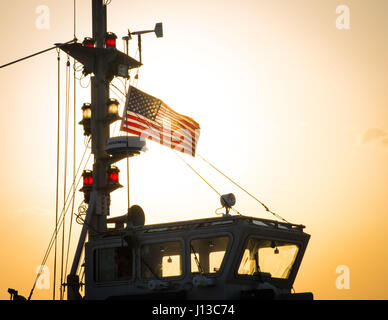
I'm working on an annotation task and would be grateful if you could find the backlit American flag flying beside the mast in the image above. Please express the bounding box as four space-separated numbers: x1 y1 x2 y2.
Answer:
121 86 200 157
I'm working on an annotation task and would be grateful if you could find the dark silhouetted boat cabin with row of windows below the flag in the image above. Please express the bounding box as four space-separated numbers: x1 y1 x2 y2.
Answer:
84 215 312 300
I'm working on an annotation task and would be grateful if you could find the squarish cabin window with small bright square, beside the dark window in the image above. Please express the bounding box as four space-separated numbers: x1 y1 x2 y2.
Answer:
141 241 182 279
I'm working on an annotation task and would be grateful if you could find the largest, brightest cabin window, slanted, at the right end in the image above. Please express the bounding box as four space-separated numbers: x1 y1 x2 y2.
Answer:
238 238 299 279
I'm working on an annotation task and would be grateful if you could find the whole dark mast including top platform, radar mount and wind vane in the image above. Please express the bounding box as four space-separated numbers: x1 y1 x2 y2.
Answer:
60 0 149 300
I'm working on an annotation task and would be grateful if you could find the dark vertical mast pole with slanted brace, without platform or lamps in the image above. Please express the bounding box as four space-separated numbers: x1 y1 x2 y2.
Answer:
67 0 111 300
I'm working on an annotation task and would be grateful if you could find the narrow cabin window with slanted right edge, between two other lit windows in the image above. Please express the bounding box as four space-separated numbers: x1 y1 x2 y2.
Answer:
190 236 229 273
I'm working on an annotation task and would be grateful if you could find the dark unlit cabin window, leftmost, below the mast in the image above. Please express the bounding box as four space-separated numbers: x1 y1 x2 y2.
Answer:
95 247 133 282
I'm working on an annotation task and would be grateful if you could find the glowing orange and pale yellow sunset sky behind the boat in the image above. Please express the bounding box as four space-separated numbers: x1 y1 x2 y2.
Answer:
0 0 388 299
